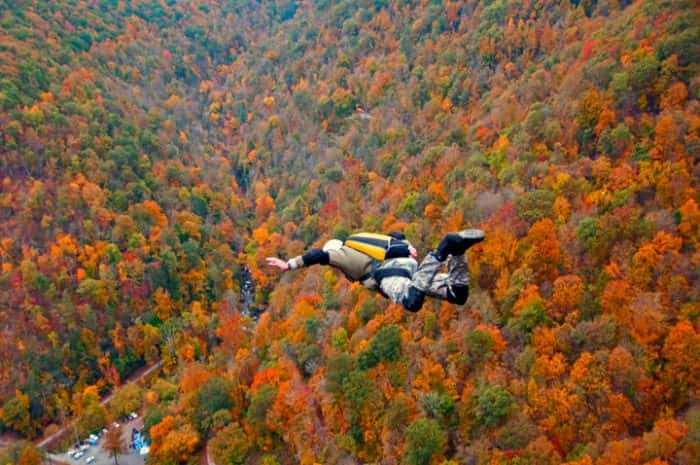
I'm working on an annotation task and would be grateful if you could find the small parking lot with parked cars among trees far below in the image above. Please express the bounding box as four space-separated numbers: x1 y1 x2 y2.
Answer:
51 418 147 465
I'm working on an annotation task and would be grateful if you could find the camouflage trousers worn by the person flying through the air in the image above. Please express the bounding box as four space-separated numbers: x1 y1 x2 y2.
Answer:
381 254 470 311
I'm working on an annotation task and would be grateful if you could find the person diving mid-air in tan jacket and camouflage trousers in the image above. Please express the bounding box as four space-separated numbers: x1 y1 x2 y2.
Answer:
265 229 485 312
